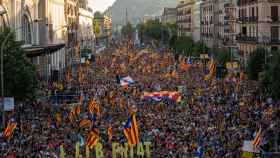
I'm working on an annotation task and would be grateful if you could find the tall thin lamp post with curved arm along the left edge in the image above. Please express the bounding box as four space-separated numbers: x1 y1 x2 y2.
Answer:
0 18 41 128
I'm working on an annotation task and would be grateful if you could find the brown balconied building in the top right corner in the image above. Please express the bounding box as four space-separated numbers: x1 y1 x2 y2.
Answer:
236 0 280 63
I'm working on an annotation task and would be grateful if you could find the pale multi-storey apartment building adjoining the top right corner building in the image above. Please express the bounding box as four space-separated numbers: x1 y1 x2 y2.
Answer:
201 0 237 51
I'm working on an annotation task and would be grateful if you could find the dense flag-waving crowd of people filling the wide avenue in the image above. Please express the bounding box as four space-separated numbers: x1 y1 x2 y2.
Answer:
0 44 280 158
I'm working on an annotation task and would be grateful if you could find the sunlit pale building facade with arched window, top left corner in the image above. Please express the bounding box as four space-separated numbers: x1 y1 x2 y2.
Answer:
0 0 65 81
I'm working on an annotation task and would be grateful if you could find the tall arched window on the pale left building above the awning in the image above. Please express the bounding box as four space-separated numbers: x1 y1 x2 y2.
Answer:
22 15 32 44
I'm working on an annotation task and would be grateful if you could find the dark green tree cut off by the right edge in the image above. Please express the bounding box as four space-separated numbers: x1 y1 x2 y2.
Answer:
262 52 280 99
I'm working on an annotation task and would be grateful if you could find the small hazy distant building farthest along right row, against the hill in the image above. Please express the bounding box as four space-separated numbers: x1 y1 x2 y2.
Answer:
161 8 177 24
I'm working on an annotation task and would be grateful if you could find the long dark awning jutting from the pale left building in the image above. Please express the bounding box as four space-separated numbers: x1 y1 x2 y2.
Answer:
23 43 65 58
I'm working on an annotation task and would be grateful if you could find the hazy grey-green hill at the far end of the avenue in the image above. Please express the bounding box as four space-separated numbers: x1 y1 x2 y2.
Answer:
105 0 180 26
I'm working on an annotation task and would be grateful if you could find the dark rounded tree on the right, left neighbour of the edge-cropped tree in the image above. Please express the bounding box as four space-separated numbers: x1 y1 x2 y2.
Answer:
246 48 265 80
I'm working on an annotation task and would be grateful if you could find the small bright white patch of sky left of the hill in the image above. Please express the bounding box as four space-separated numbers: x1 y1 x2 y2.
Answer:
88 0 116 12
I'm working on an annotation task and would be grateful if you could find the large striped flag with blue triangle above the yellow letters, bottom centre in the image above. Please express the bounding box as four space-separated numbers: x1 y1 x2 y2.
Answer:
123 114 139 145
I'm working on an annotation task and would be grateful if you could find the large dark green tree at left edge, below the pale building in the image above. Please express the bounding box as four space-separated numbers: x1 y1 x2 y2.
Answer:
0 29 38 101
